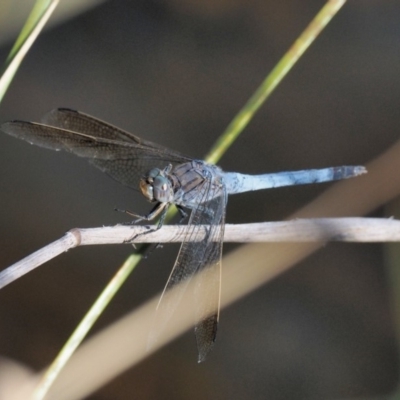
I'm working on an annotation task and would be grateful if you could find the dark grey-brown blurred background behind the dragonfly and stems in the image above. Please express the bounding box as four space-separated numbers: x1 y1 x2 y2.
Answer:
0 0 400 400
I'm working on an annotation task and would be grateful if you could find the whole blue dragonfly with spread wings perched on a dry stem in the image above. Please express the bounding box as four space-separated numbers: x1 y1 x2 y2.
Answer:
1 108 366 362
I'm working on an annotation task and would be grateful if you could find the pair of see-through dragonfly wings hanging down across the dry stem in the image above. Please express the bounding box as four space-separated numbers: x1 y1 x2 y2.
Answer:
150 175 227 362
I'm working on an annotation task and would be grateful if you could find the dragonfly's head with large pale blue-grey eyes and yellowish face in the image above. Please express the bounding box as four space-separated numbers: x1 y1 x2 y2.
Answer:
140 168 174 203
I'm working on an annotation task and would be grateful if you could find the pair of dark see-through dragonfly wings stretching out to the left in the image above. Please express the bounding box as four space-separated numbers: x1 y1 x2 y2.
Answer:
1 109 191 189
